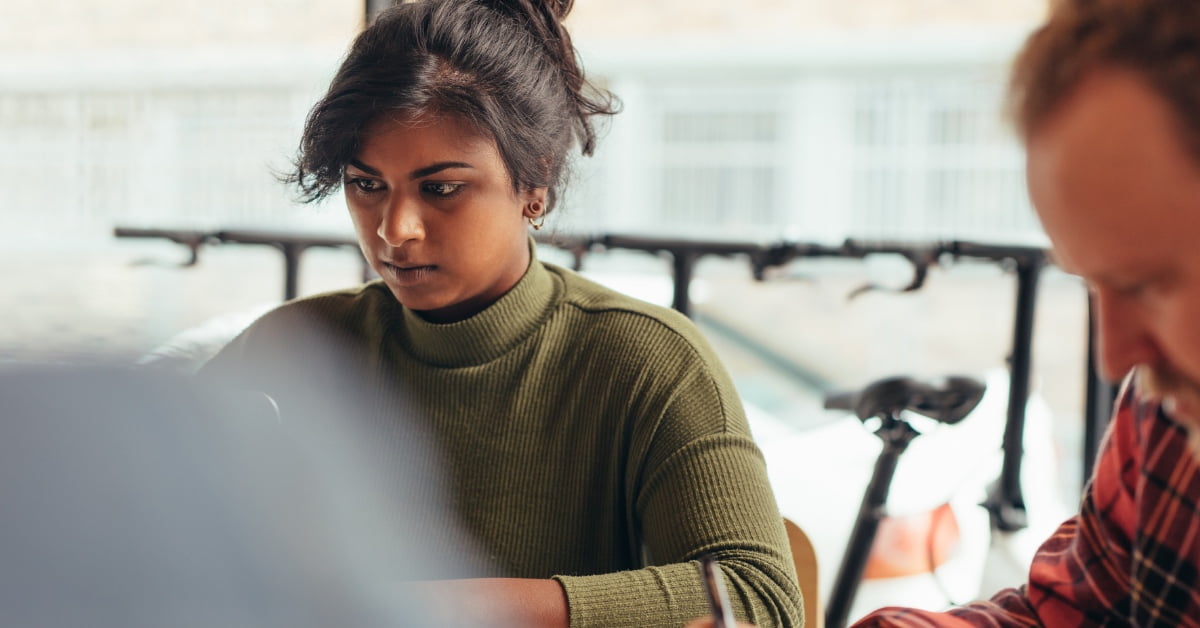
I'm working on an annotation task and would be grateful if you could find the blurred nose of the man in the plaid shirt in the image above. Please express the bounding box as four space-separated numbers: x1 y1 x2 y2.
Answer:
1092 288 1159 382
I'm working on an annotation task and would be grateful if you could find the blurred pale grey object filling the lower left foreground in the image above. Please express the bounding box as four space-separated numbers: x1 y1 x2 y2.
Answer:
0 365 496 628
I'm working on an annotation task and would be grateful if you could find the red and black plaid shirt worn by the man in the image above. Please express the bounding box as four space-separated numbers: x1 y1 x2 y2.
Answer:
856 384 1200 627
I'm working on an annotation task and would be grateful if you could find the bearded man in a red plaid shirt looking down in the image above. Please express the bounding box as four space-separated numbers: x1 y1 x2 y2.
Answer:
860 0 1200 627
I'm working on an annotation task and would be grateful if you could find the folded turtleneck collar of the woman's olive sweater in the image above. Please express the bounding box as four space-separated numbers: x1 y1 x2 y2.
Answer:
397 238 563 367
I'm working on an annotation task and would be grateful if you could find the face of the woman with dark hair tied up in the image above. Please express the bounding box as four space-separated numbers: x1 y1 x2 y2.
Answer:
344 114 546 323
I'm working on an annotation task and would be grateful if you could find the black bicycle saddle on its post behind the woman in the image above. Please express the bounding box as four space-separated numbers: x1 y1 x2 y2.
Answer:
824 376 986 425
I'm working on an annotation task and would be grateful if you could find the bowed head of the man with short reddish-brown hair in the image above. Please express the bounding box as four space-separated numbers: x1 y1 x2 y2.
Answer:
1010 0 1200 451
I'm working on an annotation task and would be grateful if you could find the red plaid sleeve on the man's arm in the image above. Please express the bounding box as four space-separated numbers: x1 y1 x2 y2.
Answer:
854 387 1141 627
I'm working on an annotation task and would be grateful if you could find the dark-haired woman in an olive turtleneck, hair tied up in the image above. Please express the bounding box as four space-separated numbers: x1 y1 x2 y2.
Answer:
205 0 803 626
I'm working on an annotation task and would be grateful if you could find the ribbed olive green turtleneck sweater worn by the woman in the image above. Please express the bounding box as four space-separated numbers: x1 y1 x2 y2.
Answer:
204 253 803 627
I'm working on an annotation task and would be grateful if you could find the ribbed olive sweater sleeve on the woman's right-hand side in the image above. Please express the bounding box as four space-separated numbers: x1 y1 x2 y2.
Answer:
556 324 804 627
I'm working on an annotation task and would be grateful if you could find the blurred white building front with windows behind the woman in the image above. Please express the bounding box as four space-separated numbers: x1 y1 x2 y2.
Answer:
0 22 1040 241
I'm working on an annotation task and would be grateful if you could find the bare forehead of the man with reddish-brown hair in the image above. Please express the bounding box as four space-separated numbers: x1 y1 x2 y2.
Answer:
1027 71 1200 282
